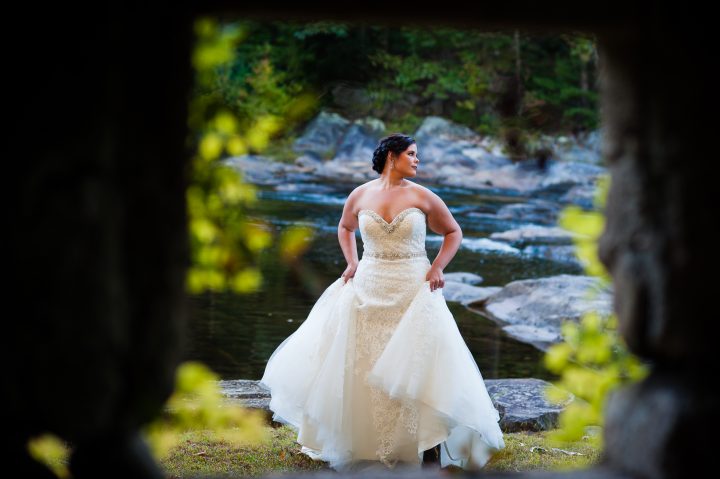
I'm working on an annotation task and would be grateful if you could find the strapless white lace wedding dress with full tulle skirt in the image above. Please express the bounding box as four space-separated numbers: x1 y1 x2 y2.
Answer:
261 207 505 471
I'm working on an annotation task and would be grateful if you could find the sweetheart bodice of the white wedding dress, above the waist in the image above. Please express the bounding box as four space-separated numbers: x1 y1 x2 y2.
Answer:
358 206 427 259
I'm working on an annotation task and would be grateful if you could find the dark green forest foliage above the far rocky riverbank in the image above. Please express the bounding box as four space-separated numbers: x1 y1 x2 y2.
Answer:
214 21 599 143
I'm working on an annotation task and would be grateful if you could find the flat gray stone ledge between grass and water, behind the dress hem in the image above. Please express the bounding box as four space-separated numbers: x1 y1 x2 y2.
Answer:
219 378 576 432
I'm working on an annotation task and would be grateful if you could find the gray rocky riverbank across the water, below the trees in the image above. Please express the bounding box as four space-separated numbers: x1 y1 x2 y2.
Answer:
225 112 607 206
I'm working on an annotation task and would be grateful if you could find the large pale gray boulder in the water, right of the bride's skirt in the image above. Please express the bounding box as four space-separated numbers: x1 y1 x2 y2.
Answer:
472 274 612 351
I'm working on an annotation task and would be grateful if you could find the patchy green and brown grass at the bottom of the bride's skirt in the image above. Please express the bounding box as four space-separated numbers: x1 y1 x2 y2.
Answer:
161 426 600 479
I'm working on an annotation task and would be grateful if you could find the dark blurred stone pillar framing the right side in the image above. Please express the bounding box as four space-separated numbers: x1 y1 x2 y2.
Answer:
600 10 720 478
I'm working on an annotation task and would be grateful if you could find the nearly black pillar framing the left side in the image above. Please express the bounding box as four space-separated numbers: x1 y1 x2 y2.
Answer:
9 3 193 479
